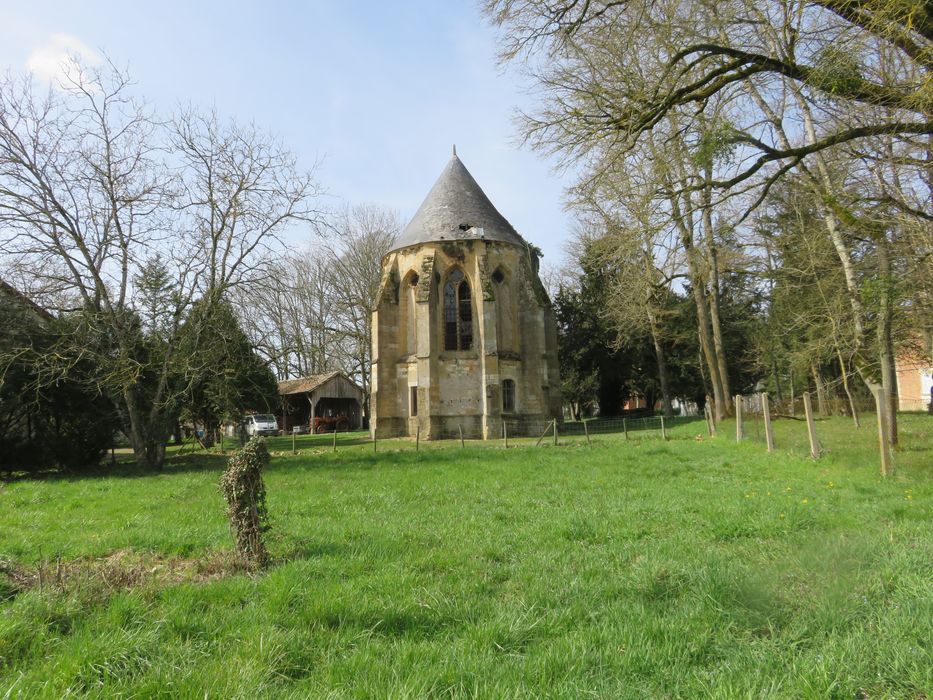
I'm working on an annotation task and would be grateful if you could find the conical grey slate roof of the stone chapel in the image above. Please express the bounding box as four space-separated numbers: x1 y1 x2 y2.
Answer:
393 151 527 250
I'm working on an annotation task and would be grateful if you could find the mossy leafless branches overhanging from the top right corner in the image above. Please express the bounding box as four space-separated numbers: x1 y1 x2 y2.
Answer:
485 0 933 193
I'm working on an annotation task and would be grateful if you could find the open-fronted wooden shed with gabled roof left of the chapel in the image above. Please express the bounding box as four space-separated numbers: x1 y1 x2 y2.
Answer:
278 372 364 433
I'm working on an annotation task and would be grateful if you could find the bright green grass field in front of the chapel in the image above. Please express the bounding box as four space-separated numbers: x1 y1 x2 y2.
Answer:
0 415 933 698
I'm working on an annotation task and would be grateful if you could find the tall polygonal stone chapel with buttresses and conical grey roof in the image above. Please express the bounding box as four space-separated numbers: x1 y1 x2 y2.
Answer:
371 150 561 439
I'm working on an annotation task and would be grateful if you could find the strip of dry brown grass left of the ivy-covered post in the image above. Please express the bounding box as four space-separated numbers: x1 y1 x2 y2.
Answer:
0 549 246 600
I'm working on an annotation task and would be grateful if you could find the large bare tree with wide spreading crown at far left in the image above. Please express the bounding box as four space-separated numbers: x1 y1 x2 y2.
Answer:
0 62 315 468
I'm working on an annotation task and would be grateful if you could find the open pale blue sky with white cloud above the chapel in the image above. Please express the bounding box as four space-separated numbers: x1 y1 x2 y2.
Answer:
0 0 571 265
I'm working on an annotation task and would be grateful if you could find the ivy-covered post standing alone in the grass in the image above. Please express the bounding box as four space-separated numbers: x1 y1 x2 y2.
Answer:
220 436 269 568
